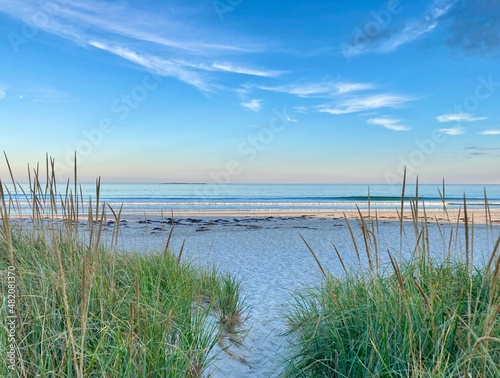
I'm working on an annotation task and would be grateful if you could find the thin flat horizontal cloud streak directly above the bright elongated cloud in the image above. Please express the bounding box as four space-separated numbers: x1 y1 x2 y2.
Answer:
252 81 375 98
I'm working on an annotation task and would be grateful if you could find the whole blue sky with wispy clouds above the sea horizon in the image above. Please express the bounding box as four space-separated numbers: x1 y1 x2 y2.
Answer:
0 0 500 184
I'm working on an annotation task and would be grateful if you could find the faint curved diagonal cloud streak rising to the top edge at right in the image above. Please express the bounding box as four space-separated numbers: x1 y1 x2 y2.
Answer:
342 0 458 57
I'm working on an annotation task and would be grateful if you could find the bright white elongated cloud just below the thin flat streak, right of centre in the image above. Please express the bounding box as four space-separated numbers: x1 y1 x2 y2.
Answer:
319 93 413 114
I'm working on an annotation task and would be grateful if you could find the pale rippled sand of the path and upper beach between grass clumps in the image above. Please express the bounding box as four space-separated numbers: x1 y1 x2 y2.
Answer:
91 216 500 377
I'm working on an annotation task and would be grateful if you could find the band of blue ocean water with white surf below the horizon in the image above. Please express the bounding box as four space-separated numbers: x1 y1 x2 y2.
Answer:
4 184 500 214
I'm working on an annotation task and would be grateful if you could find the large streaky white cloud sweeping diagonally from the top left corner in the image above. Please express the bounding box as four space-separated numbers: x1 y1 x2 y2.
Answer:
0 0 274 92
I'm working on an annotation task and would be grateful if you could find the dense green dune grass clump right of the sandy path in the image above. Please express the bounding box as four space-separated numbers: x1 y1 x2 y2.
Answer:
283 176 500 378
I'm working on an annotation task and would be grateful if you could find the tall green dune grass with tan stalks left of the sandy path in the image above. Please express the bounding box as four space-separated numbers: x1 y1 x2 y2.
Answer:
0 156 245 377
